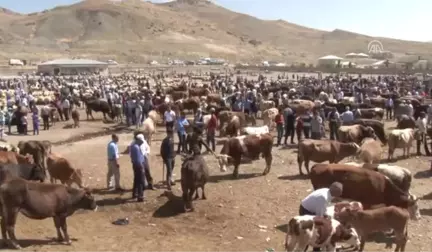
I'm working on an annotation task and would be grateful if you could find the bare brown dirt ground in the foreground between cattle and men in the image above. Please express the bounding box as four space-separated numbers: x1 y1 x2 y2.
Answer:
2 109 432 252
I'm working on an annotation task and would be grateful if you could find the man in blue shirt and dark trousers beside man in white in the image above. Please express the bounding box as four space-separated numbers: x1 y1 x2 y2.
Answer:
130 134 146 202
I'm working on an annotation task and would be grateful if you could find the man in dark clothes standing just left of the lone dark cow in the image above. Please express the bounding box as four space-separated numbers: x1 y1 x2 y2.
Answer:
160 129 175 190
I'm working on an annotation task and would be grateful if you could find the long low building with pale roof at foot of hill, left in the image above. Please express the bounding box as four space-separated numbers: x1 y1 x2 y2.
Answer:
38 59 109 75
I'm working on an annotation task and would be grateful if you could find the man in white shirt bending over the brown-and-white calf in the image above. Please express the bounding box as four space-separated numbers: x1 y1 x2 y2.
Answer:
299 182 343 252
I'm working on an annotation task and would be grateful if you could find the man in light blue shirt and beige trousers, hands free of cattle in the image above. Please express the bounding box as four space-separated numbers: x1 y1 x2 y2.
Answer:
107 134 122 190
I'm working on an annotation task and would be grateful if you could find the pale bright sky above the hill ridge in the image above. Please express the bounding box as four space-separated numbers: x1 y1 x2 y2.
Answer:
0 0 432 41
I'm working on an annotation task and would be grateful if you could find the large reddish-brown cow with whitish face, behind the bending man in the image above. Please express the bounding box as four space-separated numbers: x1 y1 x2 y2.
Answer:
310 164 421 219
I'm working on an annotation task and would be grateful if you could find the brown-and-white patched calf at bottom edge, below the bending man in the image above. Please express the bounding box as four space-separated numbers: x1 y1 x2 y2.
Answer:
285 215 360 252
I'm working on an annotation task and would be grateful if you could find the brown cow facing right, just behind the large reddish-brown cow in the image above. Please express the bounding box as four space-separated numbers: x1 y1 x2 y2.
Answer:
297 139 360 175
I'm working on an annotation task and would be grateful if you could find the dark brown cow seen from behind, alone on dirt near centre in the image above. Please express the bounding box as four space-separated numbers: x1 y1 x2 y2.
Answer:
181 155 209 212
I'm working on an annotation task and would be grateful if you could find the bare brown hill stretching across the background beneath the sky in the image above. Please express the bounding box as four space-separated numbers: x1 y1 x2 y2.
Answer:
0 0 432 62
